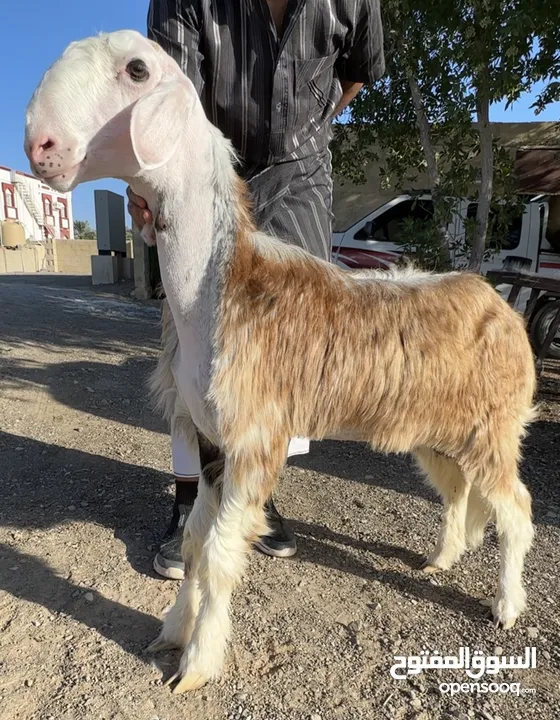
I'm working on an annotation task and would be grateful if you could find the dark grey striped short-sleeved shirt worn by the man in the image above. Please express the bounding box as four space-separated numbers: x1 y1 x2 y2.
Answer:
148 0 385 169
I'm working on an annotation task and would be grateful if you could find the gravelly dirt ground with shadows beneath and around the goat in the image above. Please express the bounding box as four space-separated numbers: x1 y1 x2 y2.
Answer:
0 276 560 720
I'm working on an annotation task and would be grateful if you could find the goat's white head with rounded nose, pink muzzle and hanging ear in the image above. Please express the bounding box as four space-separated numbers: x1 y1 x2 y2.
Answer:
24 30 198 192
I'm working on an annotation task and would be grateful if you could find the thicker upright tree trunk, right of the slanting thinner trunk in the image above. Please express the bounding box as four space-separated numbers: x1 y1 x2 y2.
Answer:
468 82 494 272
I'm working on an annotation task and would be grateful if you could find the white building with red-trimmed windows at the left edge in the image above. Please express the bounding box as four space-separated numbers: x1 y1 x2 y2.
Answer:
0 165 74 242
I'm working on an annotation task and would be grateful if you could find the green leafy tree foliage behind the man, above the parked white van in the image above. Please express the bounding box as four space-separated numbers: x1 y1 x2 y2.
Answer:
333 0 560 270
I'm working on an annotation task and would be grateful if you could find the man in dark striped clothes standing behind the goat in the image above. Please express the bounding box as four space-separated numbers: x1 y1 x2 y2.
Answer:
129 0 385 579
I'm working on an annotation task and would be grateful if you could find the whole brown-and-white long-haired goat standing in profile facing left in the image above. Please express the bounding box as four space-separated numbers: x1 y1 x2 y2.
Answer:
25 31 535 692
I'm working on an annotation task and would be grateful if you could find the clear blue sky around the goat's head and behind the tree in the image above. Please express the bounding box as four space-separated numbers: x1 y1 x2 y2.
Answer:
0 0 560 225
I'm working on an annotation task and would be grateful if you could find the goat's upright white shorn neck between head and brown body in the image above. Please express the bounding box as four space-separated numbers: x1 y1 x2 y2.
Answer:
132 123 238 340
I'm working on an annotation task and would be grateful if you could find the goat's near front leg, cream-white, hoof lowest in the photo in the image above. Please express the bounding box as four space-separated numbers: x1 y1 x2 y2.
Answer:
168 443 287 693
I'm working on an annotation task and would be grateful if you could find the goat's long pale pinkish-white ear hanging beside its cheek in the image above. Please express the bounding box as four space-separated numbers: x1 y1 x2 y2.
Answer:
130 80 193 170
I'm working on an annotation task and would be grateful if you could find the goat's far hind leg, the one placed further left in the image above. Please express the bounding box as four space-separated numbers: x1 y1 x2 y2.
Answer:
415 448 470 574
